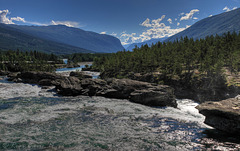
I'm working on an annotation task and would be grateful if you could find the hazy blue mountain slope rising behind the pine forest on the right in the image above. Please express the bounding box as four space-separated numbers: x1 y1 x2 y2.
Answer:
165 8 240 41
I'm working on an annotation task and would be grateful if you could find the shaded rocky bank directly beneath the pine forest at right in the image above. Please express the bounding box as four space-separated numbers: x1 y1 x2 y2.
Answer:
125 68 240 103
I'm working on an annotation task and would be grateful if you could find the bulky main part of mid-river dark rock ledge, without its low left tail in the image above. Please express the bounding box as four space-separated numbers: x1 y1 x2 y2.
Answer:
56 77 177 107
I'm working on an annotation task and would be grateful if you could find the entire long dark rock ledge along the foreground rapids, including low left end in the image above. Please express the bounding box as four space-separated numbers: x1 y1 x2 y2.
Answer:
6 72 177 107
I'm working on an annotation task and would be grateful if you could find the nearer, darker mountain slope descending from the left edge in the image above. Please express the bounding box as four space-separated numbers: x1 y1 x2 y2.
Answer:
0 24 93 54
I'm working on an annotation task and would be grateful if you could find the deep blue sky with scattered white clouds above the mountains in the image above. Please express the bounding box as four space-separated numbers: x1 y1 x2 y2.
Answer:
0 0 240 45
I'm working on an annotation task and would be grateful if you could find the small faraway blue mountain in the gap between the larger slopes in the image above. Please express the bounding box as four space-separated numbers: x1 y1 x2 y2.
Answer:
125 37 167 51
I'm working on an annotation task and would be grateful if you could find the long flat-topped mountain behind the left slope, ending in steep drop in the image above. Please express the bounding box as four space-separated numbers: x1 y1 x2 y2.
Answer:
6 25 124 53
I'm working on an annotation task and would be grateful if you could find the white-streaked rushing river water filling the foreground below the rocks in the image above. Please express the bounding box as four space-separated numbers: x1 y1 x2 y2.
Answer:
0 68 238 151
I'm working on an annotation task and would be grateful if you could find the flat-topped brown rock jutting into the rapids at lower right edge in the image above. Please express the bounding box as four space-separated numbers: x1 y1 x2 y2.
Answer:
197 96 240 135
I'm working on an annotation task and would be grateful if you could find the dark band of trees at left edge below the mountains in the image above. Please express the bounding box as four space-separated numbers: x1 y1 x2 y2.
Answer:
0 50 62 72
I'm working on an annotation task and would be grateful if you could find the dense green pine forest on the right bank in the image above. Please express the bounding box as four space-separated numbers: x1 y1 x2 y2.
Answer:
93 32 240 81
